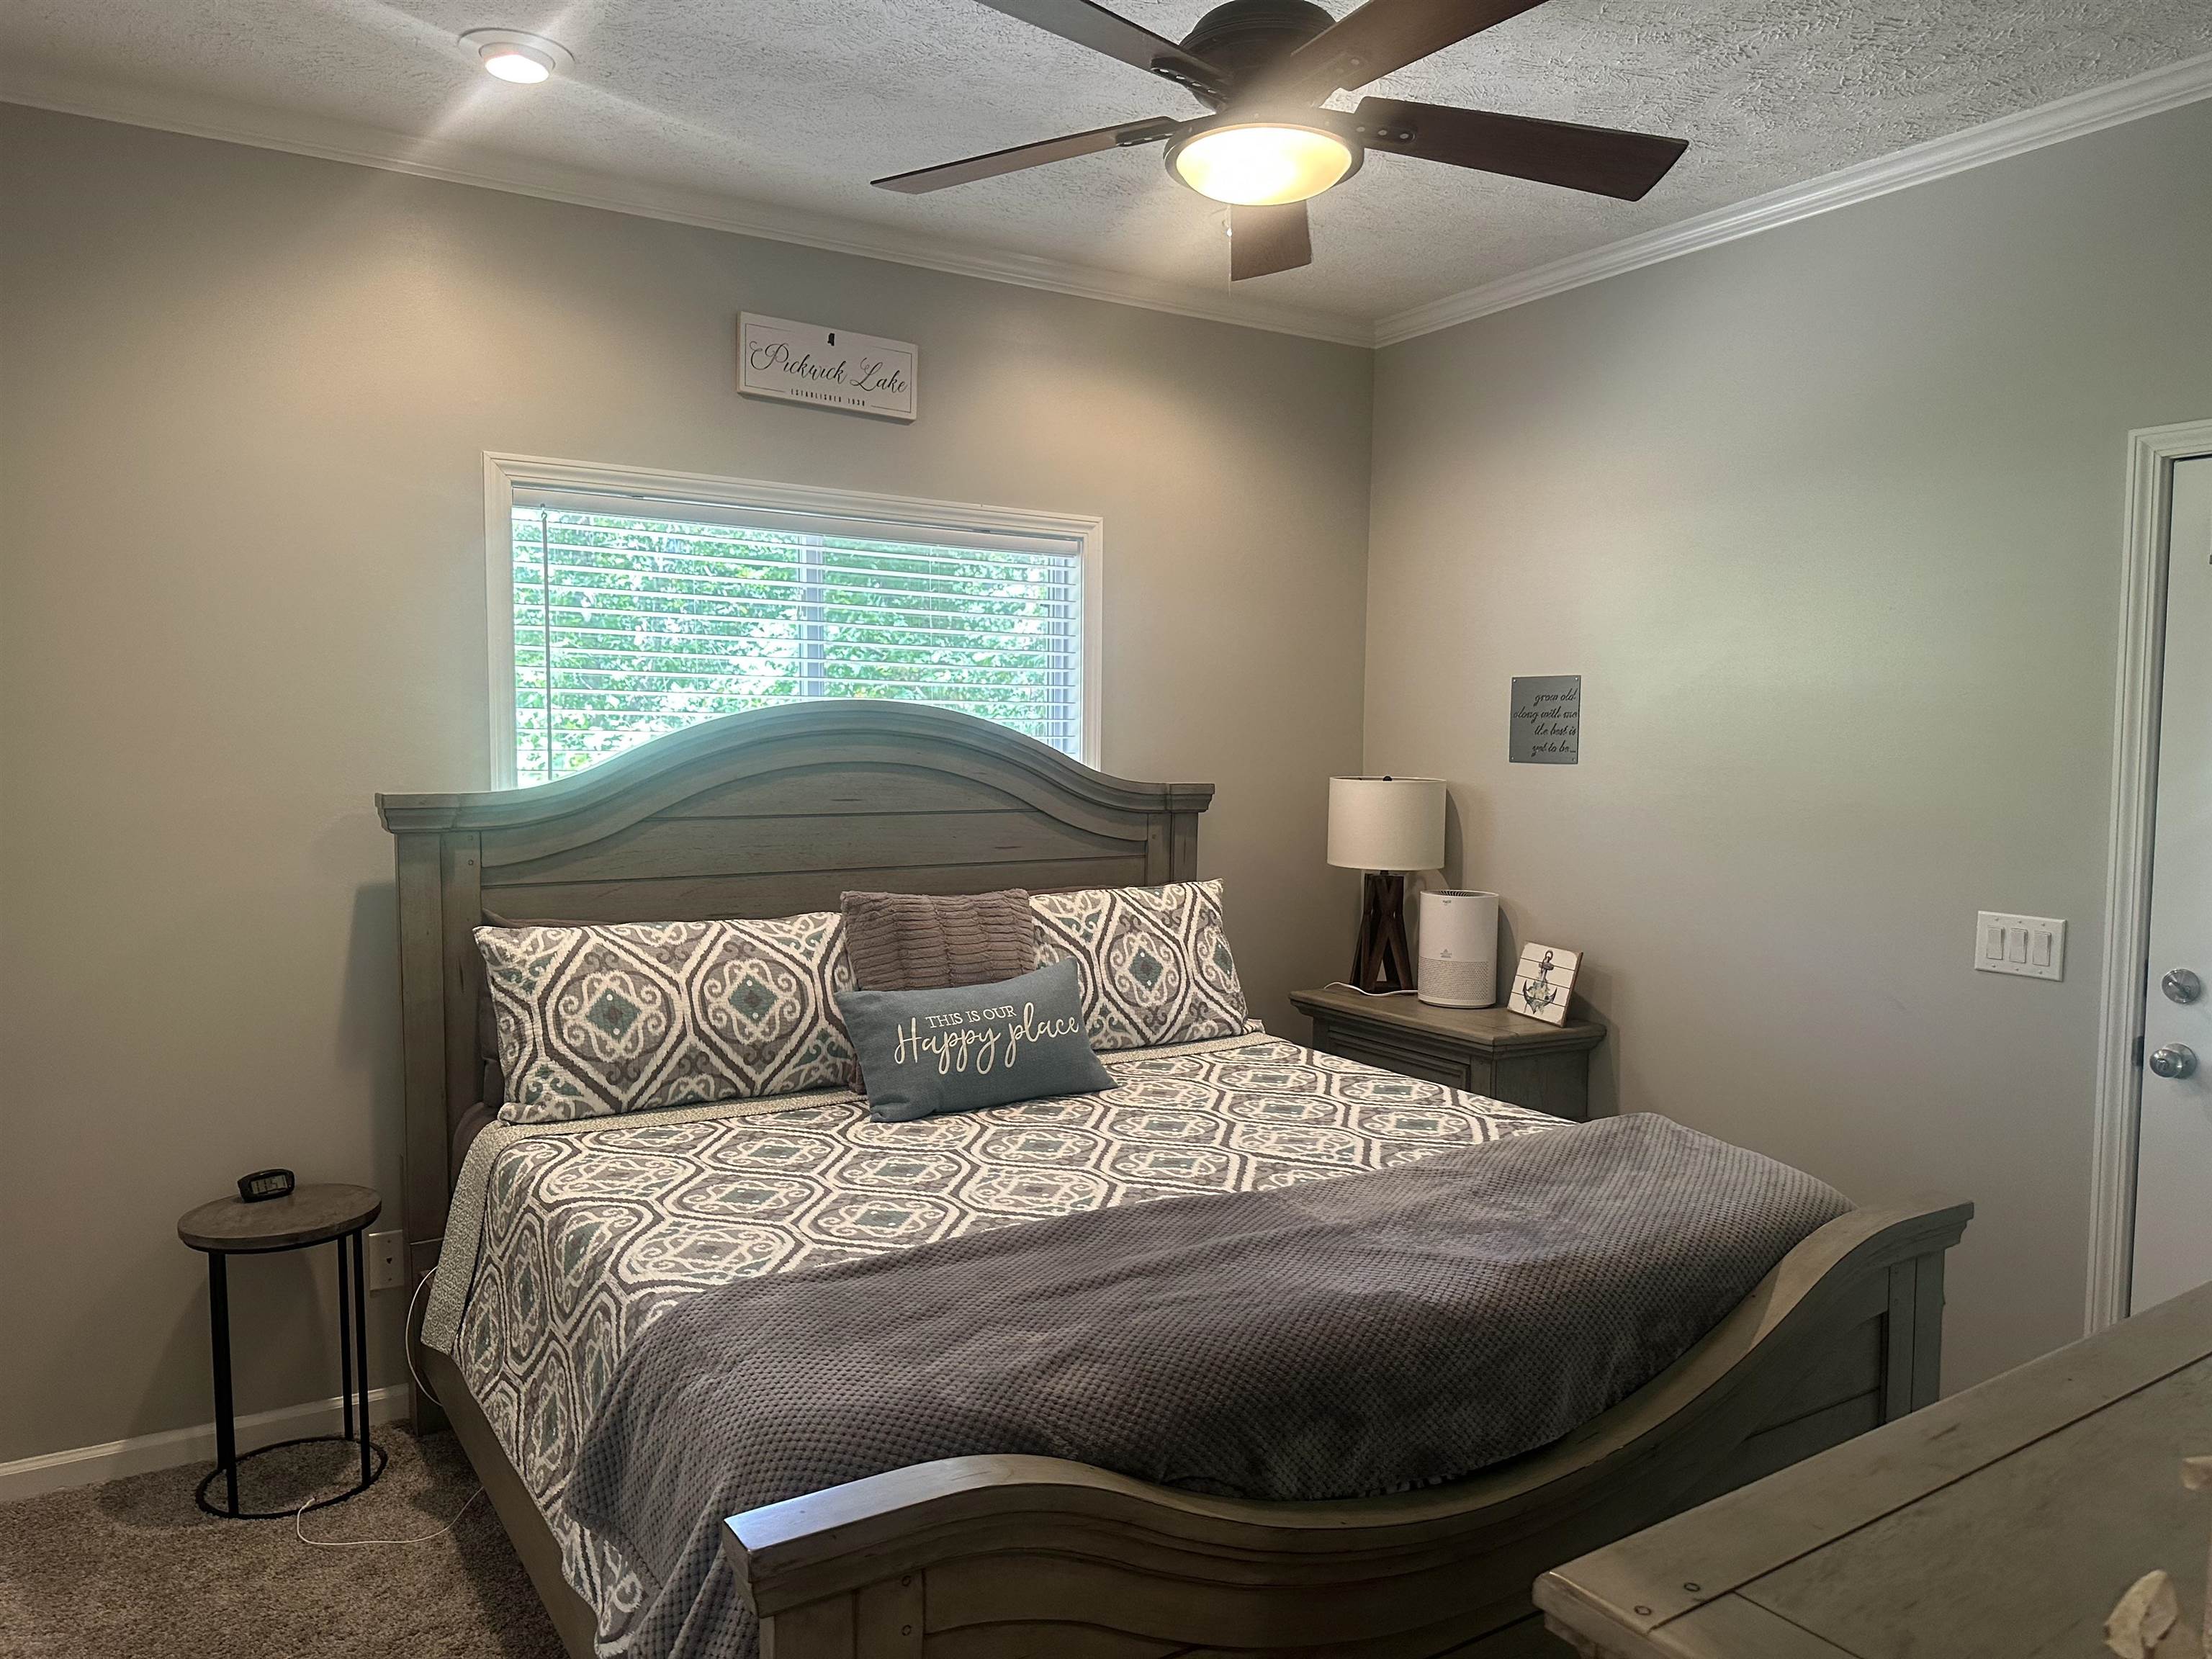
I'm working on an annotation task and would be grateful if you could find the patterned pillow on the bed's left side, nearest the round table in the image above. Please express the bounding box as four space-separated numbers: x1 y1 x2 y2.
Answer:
475 912 856 1124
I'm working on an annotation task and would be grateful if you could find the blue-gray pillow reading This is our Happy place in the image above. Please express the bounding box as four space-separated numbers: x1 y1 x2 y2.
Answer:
836 962 1112 1124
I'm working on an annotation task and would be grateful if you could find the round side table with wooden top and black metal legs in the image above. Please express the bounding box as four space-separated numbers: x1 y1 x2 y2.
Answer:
177 1186 385 1519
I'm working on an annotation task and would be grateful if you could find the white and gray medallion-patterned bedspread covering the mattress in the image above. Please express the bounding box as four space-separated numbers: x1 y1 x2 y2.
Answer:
425 1035 1562 1628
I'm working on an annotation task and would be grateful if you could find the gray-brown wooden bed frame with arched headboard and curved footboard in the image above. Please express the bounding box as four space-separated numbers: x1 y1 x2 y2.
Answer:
378 701 1973 1659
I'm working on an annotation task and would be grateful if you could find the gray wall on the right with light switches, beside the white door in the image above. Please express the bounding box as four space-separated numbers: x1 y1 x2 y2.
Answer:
1367 104 2212 1387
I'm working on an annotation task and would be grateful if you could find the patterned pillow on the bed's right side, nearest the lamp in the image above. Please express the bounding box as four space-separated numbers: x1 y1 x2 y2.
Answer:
1028 881 1248 1053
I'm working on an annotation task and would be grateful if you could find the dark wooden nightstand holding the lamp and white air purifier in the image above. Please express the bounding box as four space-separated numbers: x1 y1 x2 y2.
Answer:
1290 984 1606 1122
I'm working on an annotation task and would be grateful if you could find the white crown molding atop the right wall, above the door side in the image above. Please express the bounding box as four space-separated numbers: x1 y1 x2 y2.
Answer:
1374 53 2212 347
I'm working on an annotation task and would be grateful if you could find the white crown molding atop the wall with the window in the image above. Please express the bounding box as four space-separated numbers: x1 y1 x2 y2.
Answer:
0 68 1374 345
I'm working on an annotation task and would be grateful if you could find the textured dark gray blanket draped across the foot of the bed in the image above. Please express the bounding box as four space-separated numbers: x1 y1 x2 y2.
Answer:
569 1115 1849 1659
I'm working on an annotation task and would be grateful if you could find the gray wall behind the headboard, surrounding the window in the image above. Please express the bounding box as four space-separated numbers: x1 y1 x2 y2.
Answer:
0 106 1372 1460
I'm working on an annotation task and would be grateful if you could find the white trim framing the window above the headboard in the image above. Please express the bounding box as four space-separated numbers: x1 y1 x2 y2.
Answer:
485 451 1106 790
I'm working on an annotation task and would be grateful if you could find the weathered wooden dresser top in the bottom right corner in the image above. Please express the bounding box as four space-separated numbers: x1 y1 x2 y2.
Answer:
1535 1285 2212 1659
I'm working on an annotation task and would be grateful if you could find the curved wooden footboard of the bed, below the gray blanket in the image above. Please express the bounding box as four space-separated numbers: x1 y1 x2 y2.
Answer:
724 1203 1973 1659
